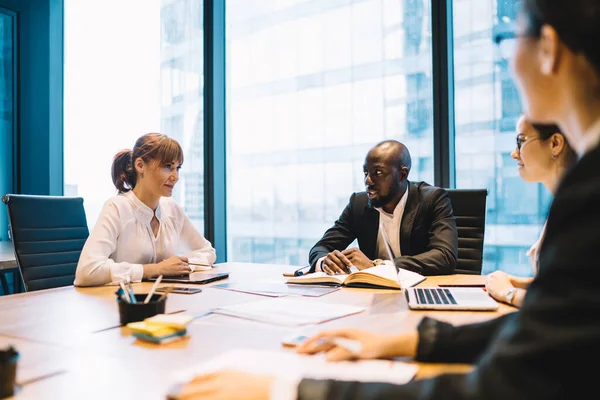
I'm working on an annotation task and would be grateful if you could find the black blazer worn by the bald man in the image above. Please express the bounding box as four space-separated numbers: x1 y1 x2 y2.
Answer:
308 182 458 275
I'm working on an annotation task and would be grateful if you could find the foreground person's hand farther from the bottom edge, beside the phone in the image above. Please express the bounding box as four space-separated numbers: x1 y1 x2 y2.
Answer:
296 329 418 361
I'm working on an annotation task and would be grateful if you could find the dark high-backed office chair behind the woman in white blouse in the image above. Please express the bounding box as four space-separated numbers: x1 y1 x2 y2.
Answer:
2 194 89 291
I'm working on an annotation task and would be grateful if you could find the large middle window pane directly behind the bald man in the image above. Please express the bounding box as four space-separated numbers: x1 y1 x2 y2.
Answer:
226 0 433 265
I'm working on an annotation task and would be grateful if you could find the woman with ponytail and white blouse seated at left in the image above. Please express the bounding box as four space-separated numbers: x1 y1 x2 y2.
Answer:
74 133 216 286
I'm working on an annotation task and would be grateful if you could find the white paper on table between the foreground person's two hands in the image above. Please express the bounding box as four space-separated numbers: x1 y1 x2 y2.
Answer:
174 349 418 385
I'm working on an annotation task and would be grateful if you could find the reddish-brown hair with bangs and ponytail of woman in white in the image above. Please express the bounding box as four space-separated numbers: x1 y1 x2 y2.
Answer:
112 133 183 193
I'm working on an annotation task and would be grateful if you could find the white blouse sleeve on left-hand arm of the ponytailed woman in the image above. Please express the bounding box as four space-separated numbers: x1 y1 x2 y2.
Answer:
74 200 144 286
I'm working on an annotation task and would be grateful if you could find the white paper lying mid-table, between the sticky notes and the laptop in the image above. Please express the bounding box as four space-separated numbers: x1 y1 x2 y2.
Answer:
213 297 365 326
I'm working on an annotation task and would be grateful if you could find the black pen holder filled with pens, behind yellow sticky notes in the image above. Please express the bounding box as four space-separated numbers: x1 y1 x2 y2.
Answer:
116 276 167 326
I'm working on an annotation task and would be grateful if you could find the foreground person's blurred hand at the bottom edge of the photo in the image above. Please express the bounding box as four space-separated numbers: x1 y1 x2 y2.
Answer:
177 370 275 400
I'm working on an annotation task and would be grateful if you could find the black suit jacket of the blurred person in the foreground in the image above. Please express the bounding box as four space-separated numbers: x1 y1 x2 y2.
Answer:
299 142 600 400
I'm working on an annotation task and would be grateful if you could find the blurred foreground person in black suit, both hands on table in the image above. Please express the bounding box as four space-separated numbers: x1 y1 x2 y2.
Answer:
182 0 600 400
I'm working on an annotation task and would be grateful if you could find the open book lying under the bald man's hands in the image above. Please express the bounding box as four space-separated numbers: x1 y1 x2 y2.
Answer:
286 264 425 289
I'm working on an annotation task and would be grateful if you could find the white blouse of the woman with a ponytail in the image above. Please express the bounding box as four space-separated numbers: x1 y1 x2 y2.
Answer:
74 191 217 286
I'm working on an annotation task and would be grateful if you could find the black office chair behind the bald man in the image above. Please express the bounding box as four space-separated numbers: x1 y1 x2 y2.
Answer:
446 189 487 275
